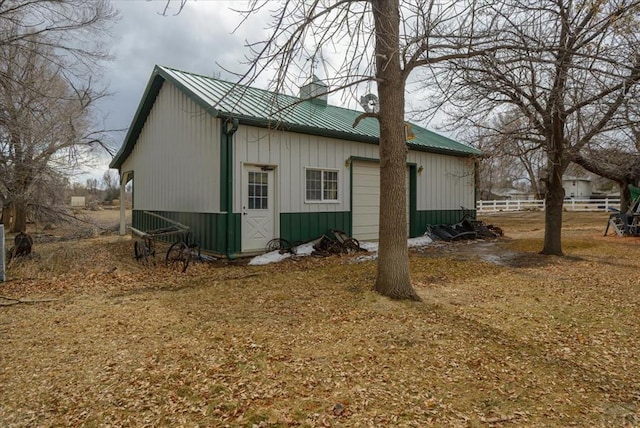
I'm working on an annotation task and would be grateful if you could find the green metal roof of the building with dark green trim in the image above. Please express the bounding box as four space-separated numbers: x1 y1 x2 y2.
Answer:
110 66 481 168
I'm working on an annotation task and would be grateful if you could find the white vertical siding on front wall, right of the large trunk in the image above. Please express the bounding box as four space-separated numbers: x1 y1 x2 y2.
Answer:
407 150 475 211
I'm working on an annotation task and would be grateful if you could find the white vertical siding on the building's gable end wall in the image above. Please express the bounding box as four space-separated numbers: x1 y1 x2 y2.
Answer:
121 82 220 213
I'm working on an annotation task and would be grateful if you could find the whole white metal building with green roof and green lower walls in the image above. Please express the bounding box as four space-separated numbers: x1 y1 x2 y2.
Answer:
110 66 480 256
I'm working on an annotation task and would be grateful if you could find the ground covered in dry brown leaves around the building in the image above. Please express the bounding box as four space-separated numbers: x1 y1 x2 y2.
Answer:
0 213 640 427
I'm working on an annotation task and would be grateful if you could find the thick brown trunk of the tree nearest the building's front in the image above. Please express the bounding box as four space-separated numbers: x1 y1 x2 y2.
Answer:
372 0 421 300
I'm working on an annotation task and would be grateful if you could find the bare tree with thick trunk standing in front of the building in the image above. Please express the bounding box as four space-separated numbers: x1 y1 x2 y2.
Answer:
160 0 496 300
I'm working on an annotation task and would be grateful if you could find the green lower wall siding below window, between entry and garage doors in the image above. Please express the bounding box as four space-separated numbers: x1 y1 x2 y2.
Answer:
280 211 351 242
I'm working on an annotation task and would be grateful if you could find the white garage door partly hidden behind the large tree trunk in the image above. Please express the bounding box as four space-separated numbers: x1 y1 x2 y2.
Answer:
351 161 409 241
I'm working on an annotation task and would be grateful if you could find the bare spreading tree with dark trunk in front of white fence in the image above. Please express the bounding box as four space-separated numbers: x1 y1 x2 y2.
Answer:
424 0 640 255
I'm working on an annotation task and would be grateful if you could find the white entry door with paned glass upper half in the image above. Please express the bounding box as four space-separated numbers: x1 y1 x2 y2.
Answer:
242 166 276 251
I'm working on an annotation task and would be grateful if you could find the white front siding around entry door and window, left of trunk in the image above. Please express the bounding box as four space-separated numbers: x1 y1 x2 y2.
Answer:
233 125 378 213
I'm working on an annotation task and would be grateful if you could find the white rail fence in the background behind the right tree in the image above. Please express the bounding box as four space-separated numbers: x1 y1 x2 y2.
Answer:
476 198 620 213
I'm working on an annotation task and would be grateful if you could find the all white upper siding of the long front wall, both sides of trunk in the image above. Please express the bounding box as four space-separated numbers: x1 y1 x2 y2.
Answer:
233 125 475 213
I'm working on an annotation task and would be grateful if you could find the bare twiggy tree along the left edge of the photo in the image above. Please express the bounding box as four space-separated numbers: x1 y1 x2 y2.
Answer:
0 0 115 231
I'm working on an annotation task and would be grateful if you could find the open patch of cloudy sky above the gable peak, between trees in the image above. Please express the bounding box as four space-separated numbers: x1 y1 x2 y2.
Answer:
93 0 266 178
